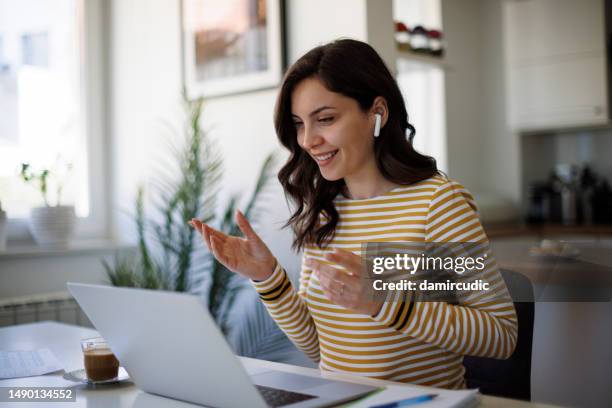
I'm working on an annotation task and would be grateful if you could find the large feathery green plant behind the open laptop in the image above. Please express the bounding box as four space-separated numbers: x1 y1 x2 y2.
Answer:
103 92 275 333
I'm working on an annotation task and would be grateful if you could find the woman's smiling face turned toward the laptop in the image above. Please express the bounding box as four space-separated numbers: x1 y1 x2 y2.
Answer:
291 78 377 184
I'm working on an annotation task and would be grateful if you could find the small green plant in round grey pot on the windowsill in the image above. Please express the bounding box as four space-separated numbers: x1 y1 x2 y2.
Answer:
20 163 76 247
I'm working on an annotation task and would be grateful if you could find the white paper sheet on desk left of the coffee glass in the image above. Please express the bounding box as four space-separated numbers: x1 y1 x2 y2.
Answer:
0 348 64 379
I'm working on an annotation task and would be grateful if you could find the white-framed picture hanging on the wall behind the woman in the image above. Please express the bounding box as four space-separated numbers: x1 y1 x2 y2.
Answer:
181 0 285 98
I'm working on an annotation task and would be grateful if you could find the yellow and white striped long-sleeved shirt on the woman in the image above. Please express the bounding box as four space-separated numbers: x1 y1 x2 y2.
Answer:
253 175 517 388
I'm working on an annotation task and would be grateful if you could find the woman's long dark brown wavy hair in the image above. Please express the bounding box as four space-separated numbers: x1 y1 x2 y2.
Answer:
274 39 438 250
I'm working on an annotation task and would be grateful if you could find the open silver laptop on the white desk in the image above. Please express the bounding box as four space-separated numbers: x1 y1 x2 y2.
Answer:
68 283 377 408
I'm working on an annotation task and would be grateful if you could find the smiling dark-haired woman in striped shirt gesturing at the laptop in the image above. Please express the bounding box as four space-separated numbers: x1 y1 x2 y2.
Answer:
192 40 517 388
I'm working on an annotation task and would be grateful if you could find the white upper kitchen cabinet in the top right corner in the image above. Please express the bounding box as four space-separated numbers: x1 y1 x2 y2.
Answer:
503 0 610 130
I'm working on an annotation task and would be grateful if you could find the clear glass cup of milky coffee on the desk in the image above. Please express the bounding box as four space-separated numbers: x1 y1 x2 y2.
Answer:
81 337 119 381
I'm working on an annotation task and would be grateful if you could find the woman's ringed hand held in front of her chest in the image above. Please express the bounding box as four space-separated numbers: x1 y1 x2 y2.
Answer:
306 248 383 316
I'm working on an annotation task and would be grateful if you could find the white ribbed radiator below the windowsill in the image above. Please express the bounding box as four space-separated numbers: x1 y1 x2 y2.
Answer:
0 292 93 327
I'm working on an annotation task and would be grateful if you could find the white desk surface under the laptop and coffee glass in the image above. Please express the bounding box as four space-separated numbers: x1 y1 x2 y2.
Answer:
0 322 547 408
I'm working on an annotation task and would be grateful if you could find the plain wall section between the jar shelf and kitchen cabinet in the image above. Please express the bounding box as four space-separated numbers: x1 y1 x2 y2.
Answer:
442 0 520 204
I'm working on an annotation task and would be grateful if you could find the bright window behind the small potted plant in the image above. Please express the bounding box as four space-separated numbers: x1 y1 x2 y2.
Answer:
0 0 106 239
